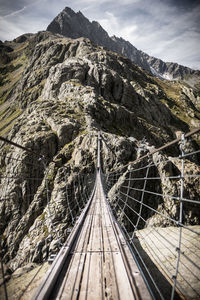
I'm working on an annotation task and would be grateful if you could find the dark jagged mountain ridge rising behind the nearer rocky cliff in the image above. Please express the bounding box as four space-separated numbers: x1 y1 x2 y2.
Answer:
47 7 200 88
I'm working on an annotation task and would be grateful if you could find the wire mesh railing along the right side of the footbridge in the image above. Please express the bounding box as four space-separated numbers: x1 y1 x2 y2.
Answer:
104 130 200 299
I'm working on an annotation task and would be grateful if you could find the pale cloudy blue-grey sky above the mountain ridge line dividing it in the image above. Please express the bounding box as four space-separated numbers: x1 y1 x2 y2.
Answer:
0 0 200 70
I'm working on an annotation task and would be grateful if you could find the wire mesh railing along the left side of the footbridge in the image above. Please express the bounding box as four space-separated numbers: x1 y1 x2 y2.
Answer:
0 137 95 300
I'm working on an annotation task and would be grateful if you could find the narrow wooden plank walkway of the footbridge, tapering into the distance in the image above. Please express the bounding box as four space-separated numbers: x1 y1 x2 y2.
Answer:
32 174 151 300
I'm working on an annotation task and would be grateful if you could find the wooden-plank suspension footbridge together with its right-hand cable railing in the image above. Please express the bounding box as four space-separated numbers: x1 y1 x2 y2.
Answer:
0 129 200 300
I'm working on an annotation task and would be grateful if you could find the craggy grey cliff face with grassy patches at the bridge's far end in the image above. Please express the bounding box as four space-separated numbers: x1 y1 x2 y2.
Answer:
0 26 200 270
